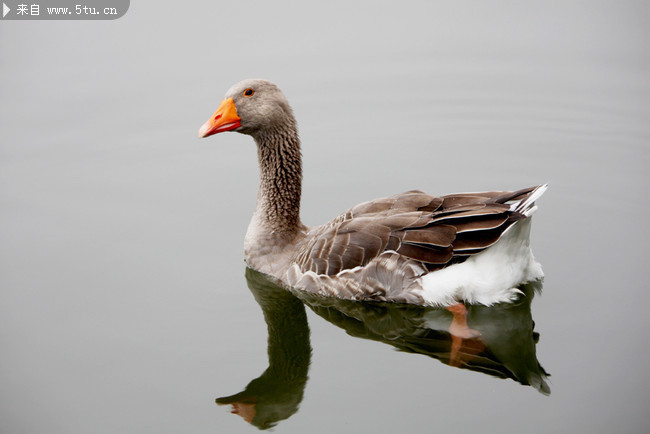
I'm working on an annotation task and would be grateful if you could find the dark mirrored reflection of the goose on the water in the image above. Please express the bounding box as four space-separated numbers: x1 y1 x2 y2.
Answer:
216 268 550 429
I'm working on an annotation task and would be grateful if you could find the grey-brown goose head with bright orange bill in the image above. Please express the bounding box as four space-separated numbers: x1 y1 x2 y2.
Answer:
199 79 295 138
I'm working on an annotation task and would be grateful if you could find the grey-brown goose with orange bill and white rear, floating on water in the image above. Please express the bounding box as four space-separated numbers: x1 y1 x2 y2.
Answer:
198 79 547 306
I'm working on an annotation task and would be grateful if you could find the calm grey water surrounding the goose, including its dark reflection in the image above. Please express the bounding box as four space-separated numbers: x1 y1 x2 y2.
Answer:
0 1 650 433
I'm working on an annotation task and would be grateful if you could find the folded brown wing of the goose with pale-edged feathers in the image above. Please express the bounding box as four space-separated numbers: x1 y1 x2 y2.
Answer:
296 187 535 275
